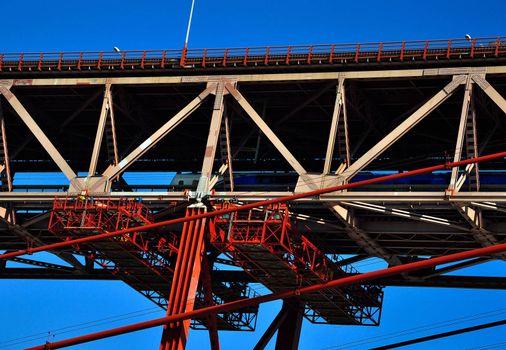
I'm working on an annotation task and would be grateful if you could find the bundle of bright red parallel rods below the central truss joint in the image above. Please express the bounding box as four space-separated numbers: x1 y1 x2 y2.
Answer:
160 207 206 350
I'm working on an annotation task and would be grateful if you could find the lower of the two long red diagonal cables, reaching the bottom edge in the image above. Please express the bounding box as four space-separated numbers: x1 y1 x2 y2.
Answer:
27 243 506 350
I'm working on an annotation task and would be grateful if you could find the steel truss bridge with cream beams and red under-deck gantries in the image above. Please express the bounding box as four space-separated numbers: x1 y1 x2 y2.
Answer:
0 37 506 349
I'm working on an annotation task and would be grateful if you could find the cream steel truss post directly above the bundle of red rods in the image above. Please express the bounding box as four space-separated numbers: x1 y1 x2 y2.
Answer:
197 83 225 196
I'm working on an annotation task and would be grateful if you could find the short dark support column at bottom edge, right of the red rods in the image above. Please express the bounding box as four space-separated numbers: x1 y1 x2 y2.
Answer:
275 298 304 350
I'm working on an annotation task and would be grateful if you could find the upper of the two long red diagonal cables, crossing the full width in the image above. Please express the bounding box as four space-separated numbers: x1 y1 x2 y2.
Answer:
0 152 506 260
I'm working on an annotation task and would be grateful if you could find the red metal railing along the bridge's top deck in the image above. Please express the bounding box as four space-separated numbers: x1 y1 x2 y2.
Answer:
0 36 506 71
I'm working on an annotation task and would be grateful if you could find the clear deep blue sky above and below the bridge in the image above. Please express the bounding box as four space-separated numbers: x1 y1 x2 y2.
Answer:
0 0 506 350
